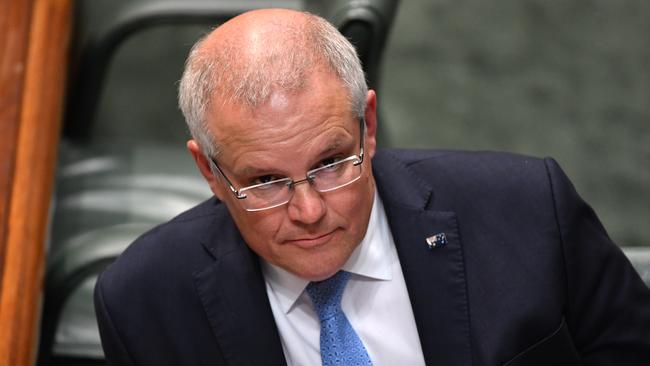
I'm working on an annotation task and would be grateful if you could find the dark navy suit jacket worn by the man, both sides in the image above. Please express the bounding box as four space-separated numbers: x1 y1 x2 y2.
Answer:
95 150 650 366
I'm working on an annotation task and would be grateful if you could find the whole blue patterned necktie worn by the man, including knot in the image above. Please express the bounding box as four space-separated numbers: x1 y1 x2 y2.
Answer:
307 271 372 366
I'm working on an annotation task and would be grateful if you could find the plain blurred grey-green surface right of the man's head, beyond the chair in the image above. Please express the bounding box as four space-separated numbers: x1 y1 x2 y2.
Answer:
379 0 650 246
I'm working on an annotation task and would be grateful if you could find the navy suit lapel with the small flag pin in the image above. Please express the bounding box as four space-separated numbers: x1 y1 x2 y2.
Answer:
373 153 472 365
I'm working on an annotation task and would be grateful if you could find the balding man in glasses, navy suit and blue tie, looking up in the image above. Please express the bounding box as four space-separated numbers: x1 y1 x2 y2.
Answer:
95 9 650 365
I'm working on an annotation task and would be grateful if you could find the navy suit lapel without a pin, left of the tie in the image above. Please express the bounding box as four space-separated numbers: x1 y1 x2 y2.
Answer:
194 206 285 365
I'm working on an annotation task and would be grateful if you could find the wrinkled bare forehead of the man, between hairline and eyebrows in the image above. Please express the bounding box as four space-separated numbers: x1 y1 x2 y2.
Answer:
208 74 358 172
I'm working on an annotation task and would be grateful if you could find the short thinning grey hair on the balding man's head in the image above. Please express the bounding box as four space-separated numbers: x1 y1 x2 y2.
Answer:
178 13 368 157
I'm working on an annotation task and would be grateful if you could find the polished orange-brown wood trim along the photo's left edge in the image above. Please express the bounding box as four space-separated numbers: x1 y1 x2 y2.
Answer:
0 0 72 366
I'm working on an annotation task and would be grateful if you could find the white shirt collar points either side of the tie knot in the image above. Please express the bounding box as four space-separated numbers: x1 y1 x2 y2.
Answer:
262 190 394 313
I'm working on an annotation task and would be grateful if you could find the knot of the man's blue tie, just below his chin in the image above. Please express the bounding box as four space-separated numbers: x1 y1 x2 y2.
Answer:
307 271 350 321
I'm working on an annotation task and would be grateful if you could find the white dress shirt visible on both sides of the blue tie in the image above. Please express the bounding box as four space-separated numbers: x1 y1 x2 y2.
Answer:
262 193 424 366
